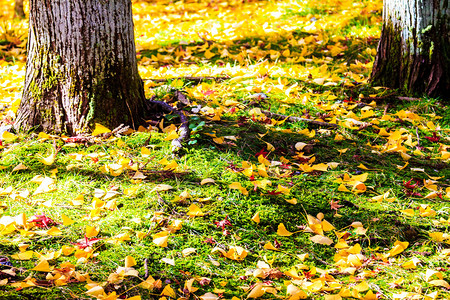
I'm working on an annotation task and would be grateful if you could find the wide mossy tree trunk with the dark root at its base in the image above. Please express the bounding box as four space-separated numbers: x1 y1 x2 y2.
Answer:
15 0 145 134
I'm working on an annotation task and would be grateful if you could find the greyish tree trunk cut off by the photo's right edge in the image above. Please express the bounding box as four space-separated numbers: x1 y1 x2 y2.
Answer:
371 0 450 96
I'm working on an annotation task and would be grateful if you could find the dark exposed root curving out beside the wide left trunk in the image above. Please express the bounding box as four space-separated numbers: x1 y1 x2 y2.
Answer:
147 92 190 152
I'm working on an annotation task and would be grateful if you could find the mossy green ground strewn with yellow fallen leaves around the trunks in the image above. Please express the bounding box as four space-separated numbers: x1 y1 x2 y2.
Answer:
0 0 450 300
